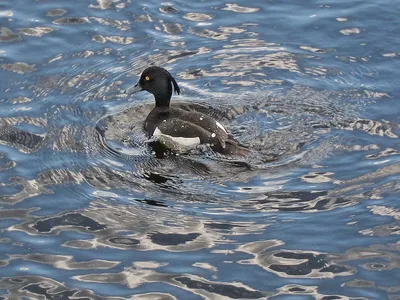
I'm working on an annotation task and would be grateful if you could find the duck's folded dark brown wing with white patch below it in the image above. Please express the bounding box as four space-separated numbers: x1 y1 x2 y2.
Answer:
153 118 228 152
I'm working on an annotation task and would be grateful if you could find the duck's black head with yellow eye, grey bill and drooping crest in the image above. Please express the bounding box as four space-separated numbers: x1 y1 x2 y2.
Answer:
125 67 180 106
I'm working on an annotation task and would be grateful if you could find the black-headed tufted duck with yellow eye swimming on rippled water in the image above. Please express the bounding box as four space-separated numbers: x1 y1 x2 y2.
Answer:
124 66 249 156
